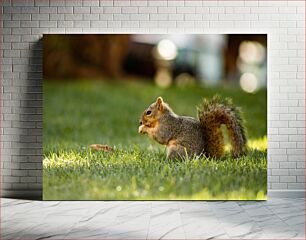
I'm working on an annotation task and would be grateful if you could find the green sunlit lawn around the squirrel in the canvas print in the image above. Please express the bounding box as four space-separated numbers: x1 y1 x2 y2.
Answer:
43 81 267 200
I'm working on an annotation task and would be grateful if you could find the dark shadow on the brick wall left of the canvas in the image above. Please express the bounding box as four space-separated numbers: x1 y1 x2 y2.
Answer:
14 39 43 200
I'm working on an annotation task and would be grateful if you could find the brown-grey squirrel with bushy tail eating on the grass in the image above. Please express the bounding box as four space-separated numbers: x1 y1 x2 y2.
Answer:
138 95 247 159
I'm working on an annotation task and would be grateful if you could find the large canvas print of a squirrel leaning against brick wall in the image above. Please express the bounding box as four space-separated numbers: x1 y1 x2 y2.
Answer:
43 34 267 200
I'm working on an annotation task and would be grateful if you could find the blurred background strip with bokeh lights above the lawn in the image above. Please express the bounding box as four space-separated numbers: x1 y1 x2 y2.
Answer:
43 34 267 93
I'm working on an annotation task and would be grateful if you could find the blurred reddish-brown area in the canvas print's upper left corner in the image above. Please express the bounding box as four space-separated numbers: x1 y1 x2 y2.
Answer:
43 34 130 78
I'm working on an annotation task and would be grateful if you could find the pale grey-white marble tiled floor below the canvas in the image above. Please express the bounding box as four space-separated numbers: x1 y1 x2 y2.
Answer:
1 198 305 239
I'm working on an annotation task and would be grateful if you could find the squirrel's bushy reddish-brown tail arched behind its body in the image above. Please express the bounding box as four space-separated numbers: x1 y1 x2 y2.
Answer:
198 95 247 157
